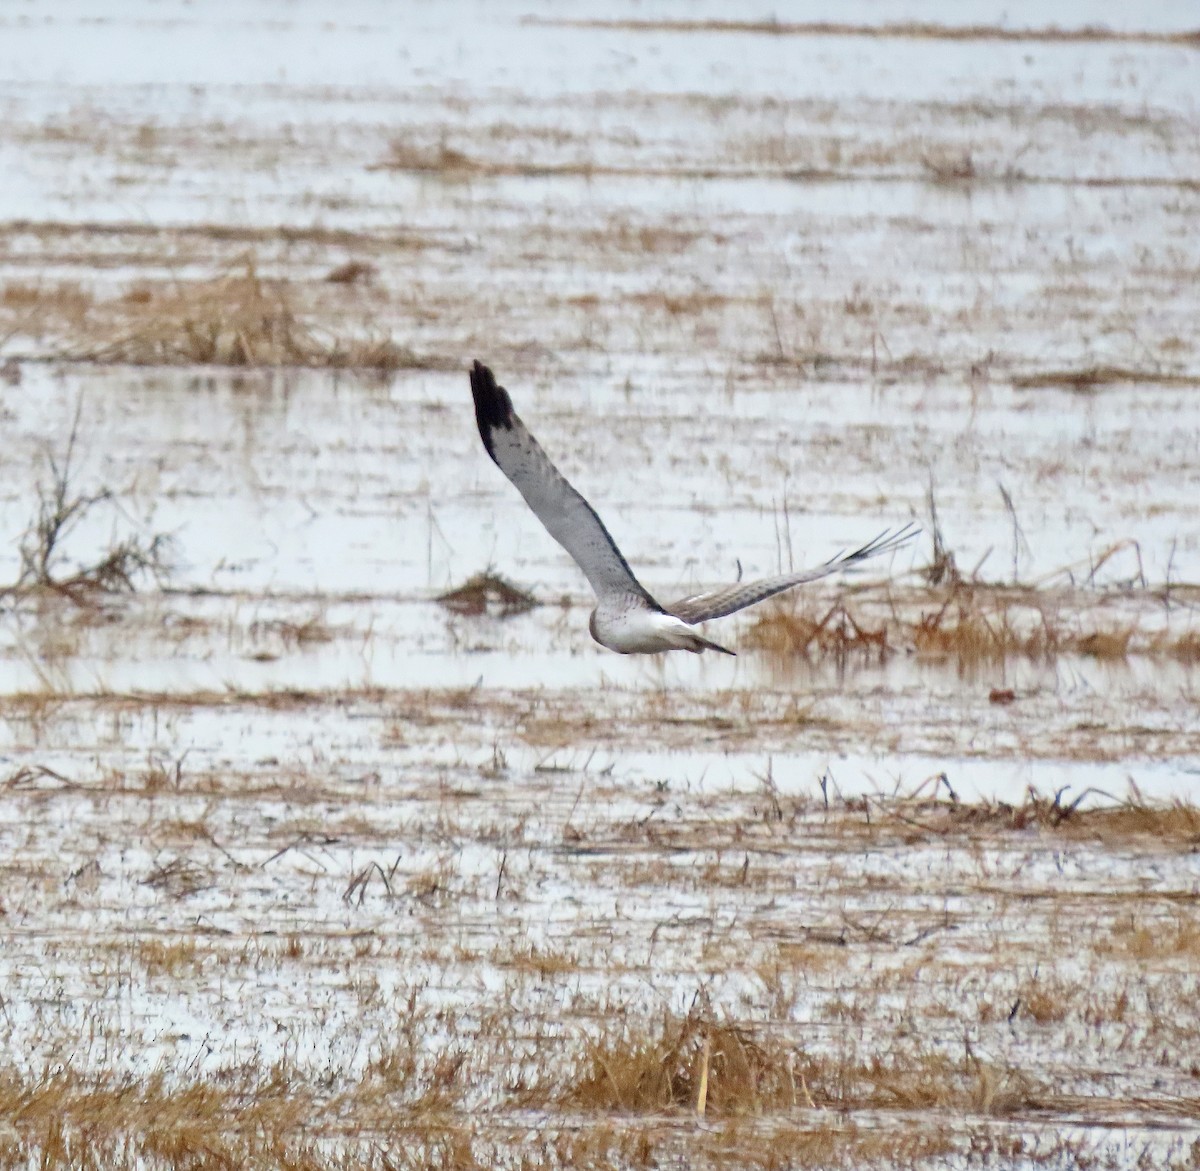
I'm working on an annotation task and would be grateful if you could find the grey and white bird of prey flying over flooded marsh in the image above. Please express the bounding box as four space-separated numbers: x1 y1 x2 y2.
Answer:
470 361 920 655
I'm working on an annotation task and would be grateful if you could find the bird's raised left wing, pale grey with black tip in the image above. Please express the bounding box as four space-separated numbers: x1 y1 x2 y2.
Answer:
470 361 659 609
